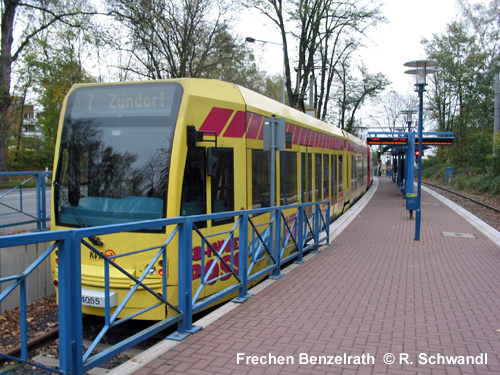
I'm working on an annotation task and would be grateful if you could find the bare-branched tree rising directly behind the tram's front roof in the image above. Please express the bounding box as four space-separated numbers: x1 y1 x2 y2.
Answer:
107 0 237 79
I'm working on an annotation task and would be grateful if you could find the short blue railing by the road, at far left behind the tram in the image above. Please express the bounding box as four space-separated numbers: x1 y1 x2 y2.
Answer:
0 172 52 230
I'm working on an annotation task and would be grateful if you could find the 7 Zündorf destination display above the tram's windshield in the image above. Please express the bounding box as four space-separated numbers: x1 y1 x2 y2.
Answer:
68 83 182 118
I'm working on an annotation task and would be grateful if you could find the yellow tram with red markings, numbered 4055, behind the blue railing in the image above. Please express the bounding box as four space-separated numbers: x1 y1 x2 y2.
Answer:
51 78 370 320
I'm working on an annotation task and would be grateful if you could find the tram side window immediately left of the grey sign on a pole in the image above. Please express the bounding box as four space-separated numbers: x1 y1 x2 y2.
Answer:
252 150 271 208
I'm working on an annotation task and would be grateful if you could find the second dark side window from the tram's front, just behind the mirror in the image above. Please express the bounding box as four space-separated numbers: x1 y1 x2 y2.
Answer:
212 148 234 225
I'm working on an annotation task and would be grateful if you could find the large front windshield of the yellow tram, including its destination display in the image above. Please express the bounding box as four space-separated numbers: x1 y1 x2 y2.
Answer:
54 83 182 229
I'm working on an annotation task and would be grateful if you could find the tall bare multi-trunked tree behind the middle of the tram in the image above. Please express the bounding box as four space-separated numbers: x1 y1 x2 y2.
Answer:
243 0 383 119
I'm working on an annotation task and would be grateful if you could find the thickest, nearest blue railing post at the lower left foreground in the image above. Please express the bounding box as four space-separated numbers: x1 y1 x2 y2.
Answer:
58 230 83 375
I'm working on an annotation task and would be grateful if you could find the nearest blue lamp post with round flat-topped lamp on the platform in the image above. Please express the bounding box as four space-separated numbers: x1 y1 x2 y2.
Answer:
404 60 438 241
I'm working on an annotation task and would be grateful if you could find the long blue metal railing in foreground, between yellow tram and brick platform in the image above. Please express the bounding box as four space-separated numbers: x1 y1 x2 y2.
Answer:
0 201 330 375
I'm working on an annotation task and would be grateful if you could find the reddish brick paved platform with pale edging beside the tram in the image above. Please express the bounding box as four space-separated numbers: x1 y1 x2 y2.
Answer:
113 177 500 375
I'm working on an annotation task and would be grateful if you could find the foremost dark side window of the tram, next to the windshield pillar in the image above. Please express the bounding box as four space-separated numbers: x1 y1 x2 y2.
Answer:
181 147 207 216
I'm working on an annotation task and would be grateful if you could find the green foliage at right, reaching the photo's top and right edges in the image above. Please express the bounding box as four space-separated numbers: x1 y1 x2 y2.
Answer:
423 0 500 174
